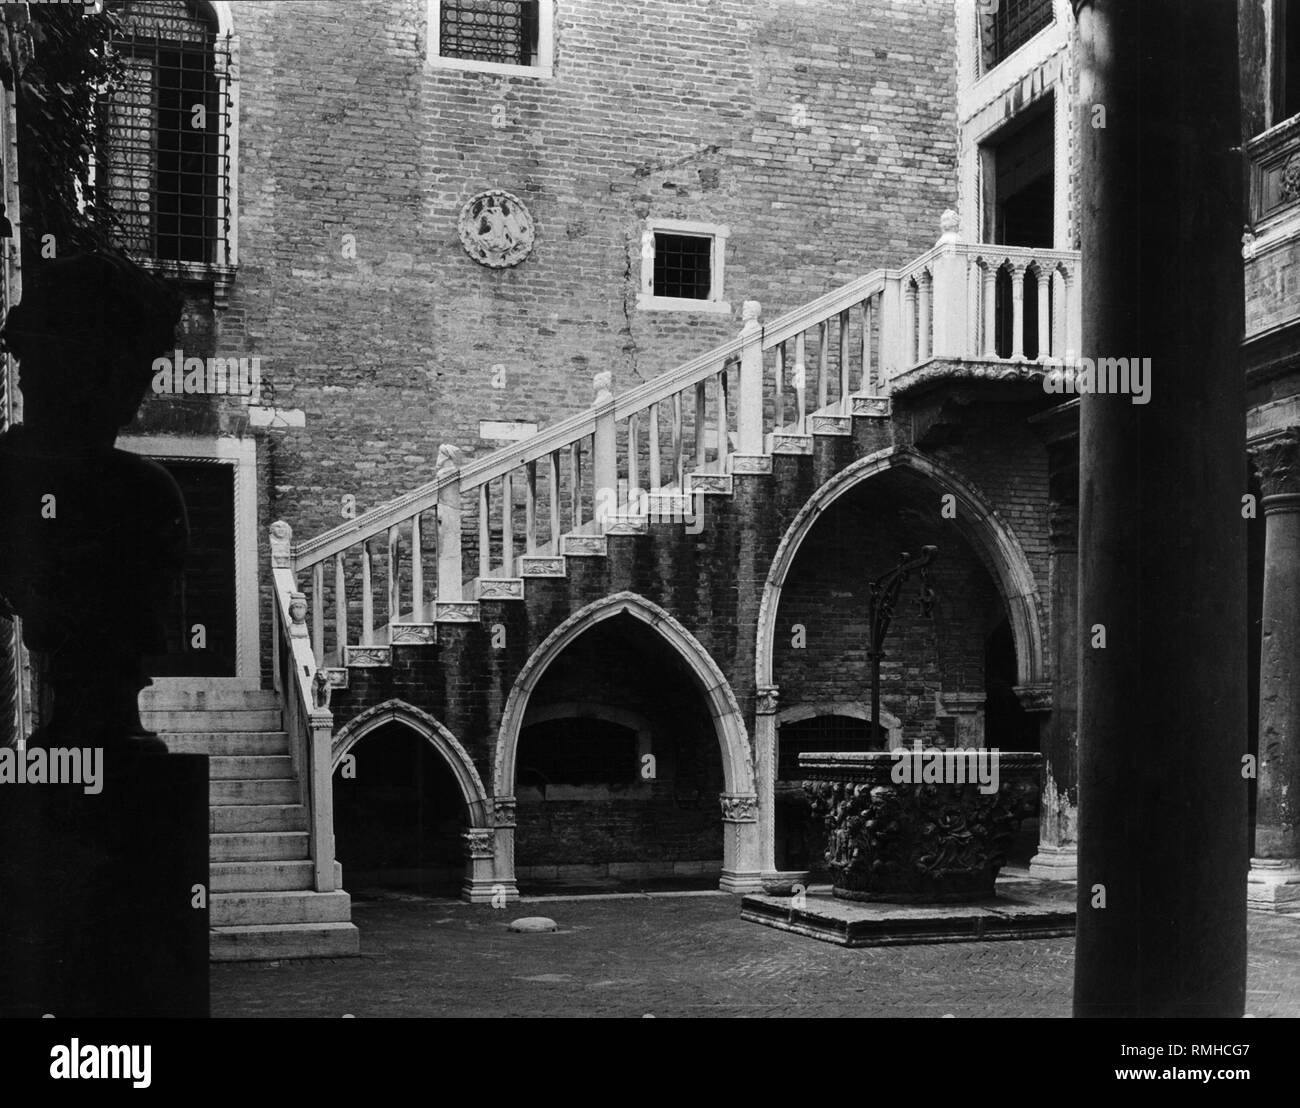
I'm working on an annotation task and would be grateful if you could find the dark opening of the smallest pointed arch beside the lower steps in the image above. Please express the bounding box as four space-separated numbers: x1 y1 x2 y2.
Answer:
334 722 468 900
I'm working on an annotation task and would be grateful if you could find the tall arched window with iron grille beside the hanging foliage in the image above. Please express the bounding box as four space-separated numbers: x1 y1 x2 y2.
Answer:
101 0 231 265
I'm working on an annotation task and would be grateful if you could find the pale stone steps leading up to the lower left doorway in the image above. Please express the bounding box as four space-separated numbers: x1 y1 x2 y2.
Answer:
140 680 359 961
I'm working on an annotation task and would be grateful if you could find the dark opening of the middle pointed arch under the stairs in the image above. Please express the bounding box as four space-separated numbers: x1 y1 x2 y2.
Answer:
515 615 724 895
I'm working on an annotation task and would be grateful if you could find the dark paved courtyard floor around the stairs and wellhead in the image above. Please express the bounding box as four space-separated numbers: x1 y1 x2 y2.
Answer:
212 892 1300 1018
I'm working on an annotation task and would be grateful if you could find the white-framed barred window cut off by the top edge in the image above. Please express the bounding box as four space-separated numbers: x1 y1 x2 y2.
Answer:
429 0 553 77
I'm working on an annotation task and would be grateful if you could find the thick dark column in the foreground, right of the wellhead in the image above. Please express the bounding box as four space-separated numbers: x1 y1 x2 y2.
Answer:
1074 0 1249 1017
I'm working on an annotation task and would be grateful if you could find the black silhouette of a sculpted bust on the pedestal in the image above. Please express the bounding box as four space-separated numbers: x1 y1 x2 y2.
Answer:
0 252 189 753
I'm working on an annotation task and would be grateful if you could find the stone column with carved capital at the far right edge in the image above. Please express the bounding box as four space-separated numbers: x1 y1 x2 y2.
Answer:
1247 429 1300 912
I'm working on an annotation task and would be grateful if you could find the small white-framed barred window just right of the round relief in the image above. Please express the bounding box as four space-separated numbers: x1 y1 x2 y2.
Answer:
637 220 731 312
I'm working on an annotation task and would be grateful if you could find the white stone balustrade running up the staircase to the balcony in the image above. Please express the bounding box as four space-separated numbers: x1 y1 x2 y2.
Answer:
261 212 1079 882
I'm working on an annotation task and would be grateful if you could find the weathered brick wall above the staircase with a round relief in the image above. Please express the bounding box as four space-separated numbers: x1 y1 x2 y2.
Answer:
189 0 954 551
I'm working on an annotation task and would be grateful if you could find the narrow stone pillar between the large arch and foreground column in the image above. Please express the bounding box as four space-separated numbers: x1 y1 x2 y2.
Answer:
1030 455 1079 880
